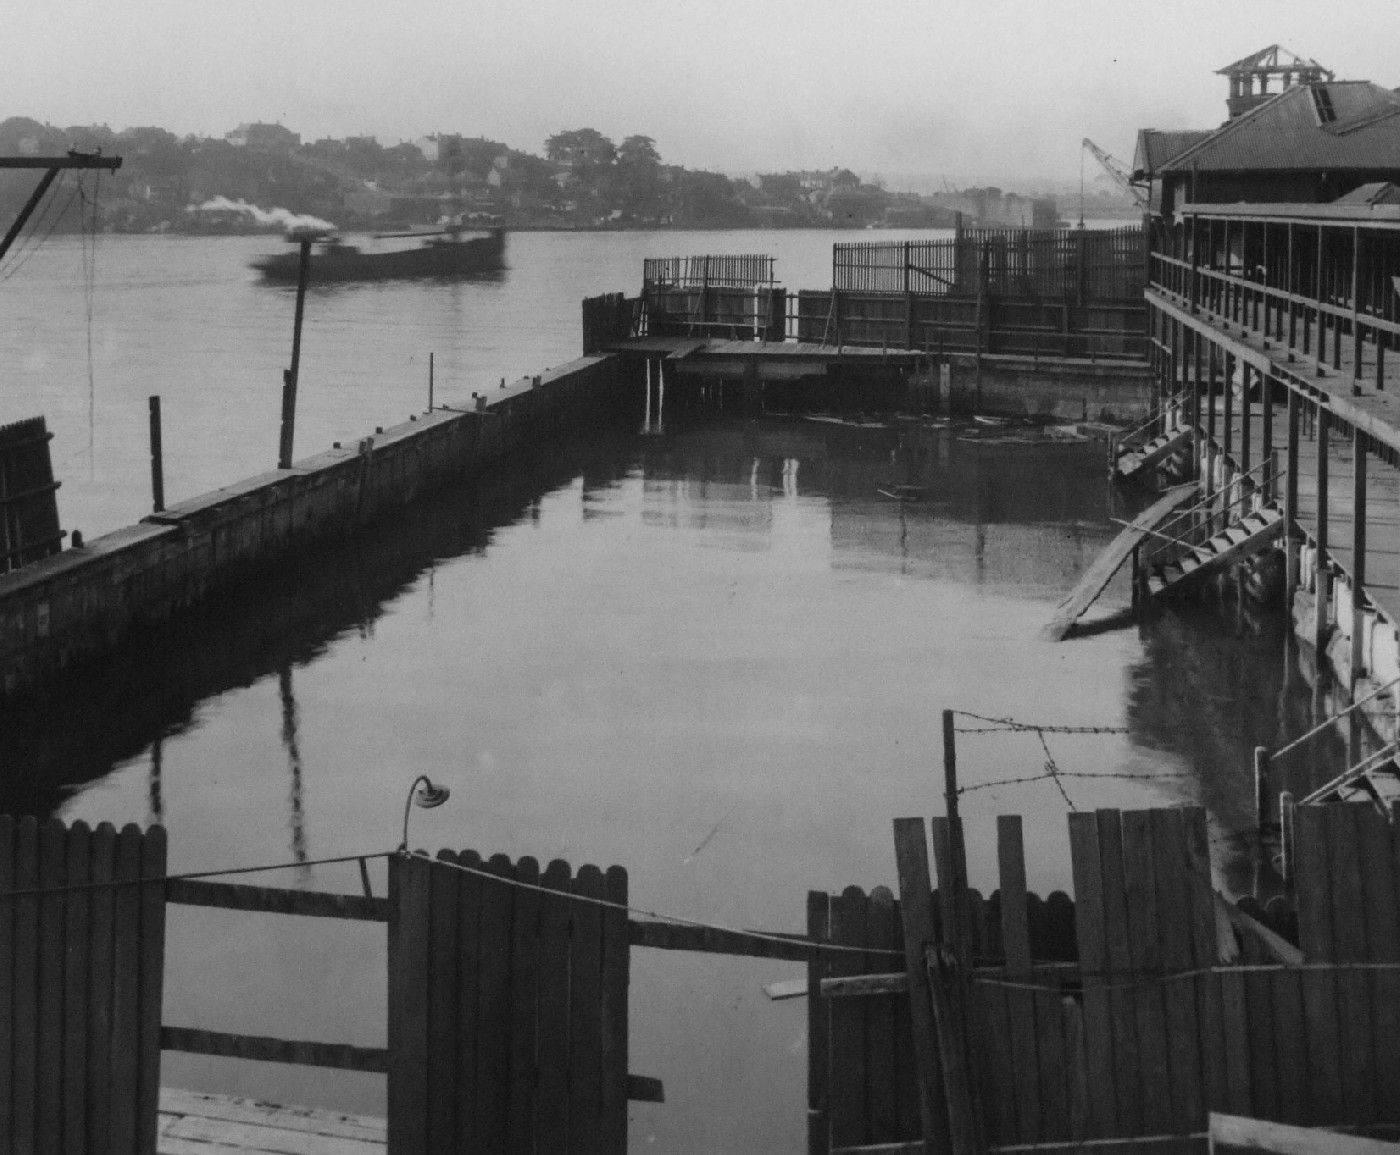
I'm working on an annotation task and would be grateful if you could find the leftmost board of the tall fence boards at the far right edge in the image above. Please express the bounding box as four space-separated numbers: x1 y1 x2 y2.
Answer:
1294 806 1343 1126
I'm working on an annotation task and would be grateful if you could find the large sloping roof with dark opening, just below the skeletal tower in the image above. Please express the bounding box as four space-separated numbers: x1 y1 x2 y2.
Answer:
1161 80 1400 172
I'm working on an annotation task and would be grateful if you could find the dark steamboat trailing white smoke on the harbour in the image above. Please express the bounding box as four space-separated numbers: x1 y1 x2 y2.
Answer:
252 228 505 284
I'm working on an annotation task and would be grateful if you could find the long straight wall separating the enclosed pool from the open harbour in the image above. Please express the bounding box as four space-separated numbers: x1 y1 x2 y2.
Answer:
0 357 630 694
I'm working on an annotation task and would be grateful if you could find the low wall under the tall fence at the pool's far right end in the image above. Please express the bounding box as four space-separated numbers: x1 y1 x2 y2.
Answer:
939 354 1152 421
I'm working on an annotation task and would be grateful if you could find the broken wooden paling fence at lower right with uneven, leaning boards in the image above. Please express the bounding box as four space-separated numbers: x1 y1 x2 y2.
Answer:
809 805 1400 1152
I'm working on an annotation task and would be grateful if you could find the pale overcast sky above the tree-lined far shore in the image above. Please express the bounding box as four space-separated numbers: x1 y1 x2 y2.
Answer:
10 0 1400 188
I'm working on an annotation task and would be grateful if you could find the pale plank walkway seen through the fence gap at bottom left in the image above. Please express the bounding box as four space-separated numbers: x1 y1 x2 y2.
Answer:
155 1088 386 1155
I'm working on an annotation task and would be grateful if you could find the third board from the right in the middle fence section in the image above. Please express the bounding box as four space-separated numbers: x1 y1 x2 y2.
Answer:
535 858 573 1155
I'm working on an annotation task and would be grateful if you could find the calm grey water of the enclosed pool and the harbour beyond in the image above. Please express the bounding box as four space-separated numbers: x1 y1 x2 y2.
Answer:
0 232 1332 1152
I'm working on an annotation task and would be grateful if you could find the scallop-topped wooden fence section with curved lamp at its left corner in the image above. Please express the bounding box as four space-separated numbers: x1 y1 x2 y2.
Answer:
389 851 629 1155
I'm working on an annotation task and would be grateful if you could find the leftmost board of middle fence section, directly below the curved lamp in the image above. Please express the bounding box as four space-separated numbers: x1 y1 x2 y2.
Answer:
388 854 431 1151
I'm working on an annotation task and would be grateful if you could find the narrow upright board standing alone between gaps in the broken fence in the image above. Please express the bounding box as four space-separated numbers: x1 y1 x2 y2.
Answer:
997 815 1044 1142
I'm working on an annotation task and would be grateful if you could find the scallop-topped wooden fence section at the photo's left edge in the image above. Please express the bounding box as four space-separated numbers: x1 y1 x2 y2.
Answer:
0 816 165 1155
